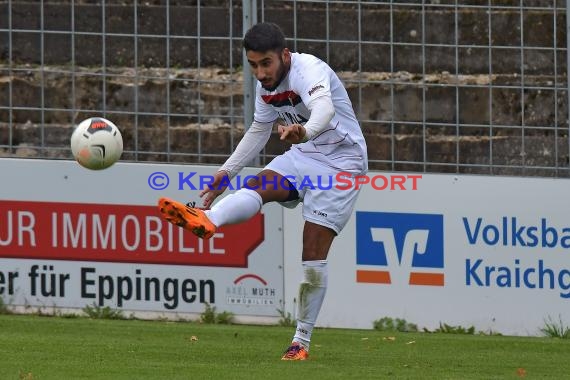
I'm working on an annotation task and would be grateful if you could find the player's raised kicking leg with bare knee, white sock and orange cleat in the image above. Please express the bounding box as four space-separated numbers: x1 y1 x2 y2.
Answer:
159 169 298 238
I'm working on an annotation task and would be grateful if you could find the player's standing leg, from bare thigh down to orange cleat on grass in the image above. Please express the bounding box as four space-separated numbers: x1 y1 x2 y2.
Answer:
282 221 336 360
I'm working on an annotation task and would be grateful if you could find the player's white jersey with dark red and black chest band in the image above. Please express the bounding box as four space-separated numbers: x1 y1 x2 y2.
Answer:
254 53 368 174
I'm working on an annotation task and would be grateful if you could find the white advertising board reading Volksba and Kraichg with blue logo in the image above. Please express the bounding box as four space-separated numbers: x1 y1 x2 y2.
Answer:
284 172 570 335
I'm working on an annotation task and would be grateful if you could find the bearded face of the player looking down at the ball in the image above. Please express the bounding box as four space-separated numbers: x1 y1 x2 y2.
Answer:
246 48 291 91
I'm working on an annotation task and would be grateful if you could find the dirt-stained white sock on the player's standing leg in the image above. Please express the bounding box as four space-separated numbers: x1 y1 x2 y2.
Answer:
293 260 328 351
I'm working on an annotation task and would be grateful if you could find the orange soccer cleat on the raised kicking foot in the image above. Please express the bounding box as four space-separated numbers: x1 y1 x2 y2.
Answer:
158 197 216 239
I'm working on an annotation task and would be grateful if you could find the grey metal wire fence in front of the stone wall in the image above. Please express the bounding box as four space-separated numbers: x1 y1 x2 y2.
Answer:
0 0 570 177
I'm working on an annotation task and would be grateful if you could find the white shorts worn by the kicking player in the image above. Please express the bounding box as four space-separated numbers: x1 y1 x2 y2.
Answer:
265 148 360 235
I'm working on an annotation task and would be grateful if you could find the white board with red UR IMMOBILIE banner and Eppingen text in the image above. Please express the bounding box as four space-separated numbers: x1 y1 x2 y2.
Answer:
0 159 284 319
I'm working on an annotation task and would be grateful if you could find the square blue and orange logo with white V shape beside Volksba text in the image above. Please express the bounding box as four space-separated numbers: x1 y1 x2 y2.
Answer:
356 211 444 286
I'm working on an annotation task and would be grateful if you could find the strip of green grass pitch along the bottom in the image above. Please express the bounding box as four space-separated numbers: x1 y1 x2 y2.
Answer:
0 315 570 380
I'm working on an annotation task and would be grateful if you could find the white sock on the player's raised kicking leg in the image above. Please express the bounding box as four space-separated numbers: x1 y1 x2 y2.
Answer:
205 188 263 227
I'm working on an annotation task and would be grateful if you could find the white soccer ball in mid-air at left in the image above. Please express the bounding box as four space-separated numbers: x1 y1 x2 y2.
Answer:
71 117 123 170
